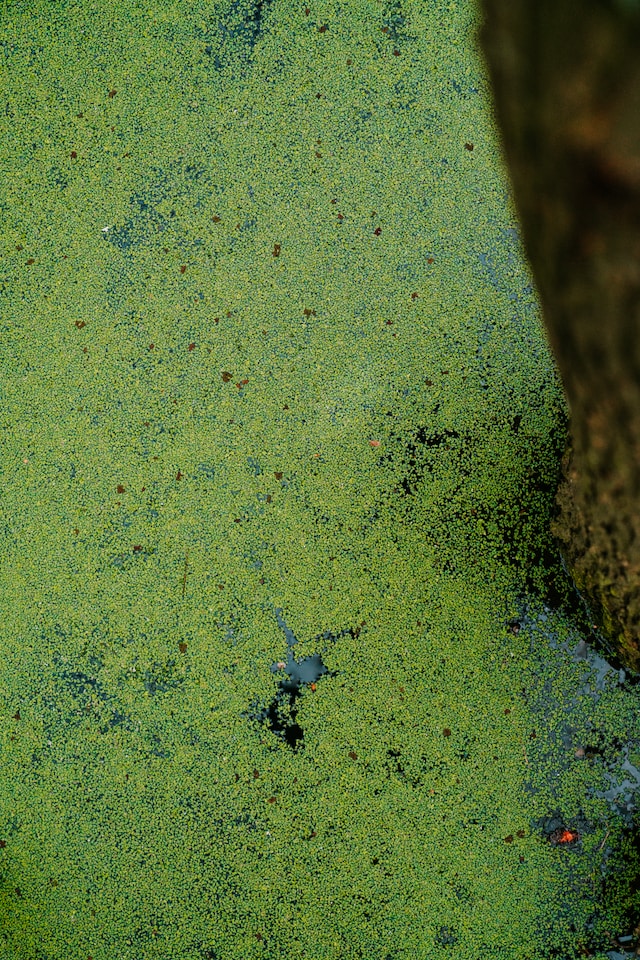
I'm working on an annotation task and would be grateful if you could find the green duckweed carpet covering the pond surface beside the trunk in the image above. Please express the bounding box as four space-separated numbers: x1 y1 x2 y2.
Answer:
0 0 640 960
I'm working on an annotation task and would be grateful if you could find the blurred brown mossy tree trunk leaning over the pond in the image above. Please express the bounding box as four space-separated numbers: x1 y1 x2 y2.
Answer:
481 0 640 670
